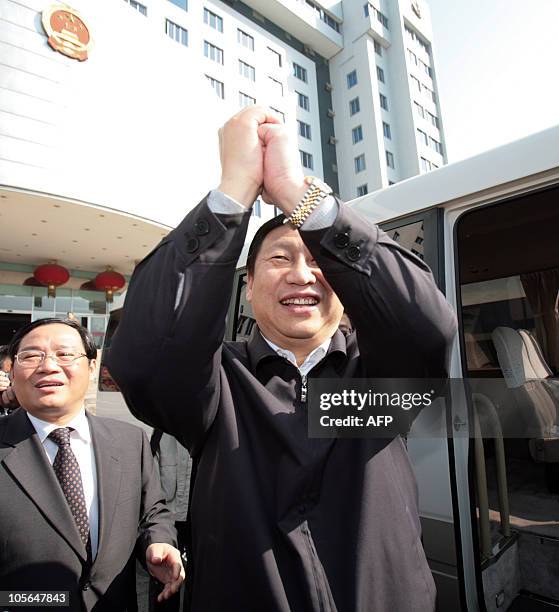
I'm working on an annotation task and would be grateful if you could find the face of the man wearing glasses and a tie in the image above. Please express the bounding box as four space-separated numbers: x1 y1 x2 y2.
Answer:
12 323 95 425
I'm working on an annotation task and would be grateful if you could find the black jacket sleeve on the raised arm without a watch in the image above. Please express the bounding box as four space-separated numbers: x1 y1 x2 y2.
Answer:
108 200 250 454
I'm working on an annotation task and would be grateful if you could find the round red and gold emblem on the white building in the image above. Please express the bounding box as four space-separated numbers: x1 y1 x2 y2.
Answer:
43 4 92 62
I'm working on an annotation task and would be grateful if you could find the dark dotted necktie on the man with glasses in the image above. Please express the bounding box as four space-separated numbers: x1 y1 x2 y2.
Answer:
48 427 91 557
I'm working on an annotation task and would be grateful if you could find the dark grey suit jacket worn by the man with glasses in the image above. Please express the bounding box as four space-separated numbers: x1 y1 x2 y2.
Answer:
0 409 176 612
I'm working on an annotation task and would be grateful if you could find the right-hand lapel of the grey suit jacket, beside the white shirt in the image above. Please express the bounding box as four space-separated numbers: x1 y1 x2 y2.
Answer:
88 415 122 560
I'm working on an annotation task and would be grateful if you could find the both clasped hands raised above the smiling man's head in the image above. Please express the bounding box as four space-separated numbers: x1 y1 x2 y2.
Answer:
219 106 307 216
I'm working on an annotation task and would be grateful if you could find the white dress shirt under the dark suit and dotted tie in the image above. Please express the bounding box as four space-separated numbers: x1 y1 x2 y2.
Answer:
27 409 99 559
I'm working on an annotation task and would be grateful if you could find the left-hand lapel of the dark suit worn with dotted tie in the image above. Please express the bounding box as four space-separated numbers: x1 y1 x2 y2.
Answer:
3 409 86 561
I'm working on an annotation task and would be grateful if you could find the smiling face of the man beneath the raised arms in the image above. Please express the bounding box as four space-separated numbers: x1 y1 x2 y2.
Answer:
247 225 343 363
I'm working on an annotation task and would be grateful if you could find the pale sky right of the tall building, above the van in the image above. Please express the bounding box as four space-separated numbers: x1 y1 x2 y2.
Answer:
427 0 559 163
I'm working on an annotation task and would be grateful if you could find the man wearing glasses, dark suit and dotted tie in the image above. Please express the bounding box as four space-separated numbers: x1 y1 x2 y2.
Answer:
0 319 184 611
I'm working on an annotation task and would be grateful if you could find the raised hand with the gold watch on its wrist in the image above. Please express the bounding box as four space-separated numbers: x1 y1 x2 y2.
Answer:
258 123 307 216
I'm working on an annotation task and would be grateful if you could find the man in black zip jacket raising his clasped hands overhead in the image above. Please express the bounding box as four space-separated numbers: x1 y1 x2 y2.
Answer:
109 107 456 612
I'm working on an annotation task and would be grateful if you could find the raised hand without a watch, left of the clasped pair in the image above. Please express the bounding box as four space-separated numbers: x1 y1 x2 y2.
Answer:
219 106 279 208
